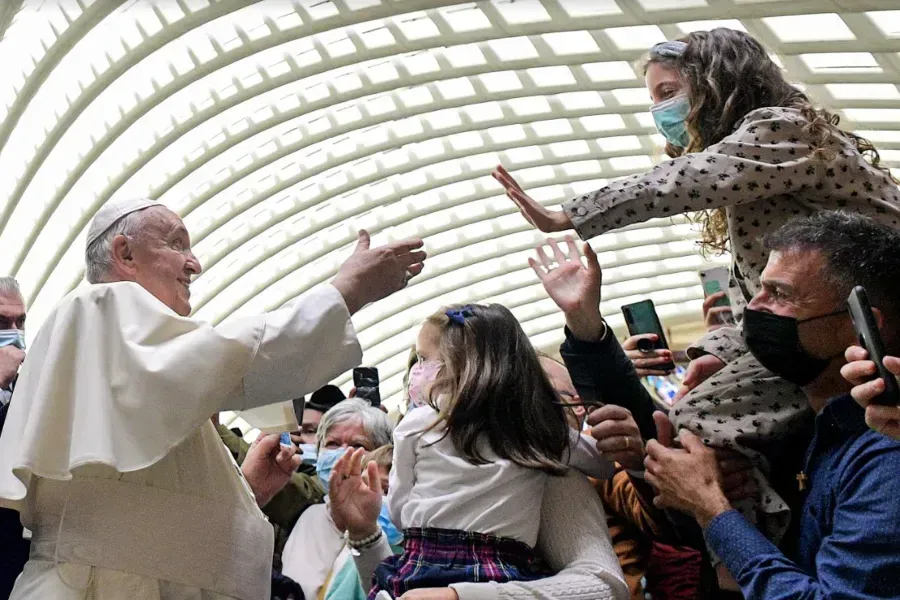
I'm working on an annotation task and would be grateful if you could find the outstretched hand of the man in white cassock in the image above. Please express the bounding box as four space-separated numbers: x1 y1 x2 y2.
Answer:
332 230 426 314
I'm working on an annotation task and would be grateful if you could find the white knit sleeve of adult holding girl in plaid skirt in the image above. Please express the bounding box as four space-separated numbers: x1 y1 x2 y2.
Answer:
450 472 629 600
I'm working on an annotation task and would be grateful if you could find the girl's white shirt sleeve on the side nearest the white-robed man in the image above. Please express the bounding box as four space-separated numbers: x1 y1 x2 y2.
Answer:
387 406 437 530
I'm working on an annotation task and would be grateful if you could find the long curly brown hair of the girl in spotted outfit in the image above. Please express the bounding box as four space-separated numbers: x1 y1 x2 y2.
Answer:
644 28 896 252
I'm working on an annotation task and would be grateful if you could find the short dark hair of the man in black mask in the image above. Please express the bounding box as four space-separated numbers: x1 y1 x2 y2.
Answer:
763 211 900 339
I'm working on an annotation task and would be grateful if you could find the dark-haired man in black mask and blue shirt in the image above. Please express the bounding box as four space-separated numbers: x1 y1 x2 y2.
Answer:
646 212 900 600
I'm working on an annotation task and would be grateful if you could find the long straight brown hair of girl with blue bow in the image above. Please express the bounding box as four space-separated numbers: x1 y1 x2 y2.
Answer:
426 304 569 475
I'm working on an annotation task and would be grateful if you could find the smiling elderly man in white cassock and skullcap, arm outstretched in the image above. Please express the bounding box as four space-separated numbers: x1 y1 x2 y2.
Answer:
0 199 425 600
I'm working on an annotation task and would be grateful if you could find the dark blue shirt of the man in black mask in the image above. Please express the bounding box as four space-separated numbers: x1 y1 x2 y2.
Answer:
706 395 900 600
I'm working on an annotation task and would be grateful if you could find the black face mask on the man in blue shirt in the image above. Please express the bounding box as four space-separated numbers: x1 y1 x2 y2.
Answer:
744 308 847 387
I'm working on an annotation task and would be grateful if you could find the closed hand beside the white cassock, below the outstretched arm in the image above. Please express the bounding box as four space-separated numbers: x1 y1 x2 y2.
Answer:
241 434 303 507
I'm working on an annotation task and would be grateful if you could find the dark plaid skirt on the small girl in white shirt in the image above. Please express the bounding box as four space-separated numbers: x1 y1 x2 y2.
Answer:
369 528 553 600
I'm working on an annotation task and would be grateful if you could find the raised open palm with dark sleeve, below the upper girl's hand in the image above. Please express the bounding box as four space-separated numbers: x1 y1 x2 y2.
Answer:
528 236 606 342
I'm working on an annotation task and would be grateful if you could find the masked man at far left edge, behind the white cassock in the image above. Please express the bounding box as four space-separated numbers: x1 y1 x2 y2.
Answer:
0 277 29 598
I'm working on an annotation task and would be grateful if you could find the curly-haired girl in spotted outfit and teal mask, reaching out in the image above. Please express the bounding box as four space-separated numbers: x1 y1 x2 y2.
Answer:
494 28 900 576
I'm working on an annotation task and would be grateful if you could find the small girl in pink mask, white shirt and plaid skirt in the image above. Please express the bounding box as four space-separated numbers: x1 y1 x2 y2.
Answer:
356 304 621 598
